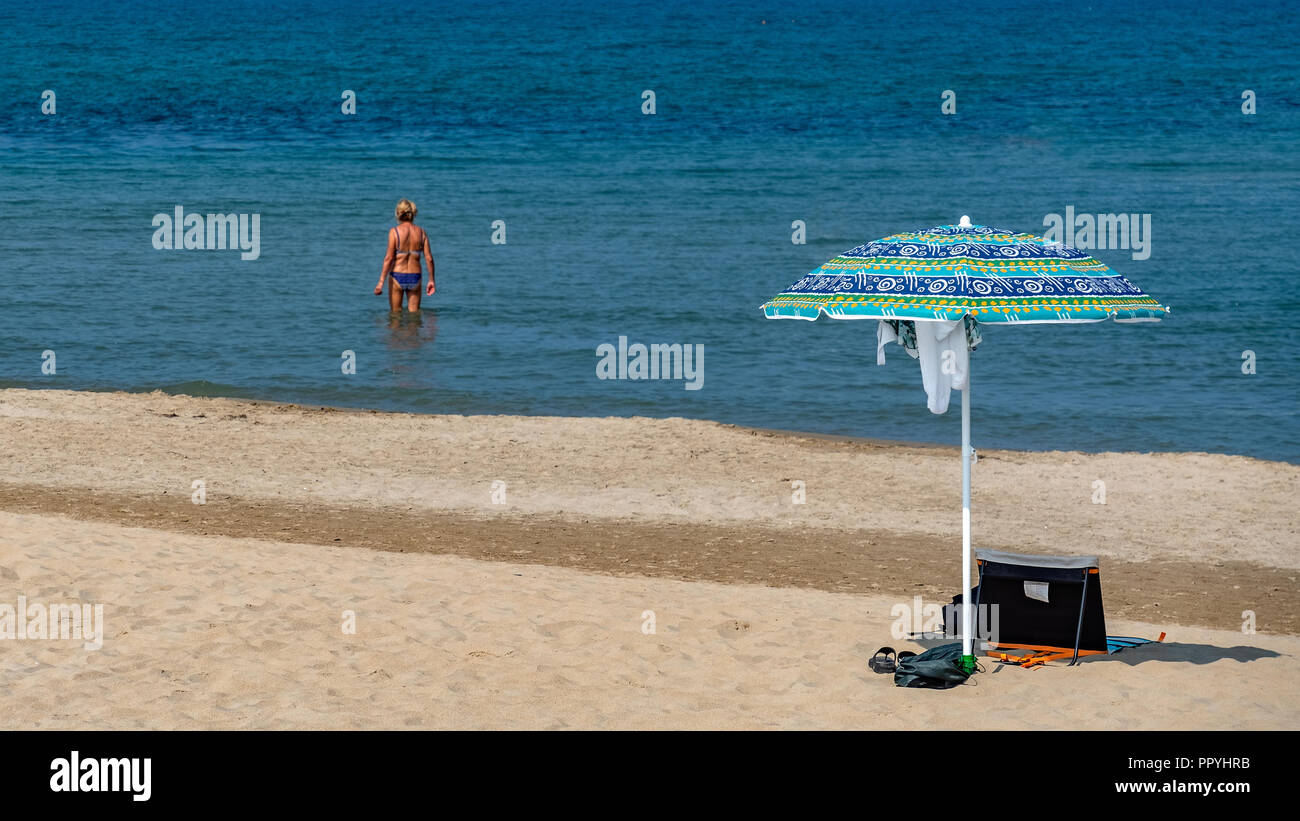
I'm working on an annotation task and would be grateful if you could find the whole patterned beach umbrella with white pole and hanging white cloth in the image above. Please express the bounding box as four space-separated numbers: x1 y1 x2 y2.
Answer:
763 217 1169 673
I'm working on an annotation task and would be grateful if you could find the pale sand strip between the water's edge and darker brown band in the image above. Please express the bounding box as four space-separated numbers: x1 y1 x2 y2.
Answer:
0 390 1300 570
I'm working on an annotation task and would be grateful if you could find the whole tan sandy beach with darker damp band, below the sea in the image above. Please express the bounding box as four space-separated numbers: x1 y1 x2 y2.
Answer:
0 390 1300 729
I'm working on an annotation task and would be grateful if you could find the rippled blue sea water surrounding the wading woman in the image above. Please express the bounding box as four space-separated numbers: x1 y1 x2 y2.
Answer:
0 1 1300 461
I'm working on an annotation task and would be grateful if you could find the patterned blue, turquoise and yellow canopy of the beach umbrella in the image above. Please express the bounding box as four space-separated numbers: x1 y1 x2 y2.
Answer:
763 217 1169 322
